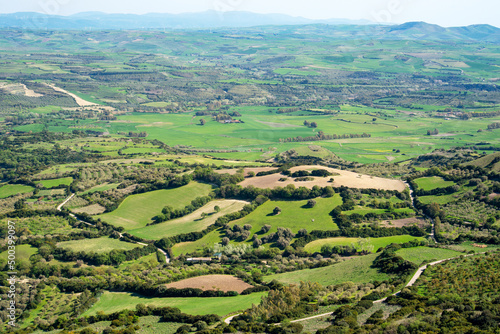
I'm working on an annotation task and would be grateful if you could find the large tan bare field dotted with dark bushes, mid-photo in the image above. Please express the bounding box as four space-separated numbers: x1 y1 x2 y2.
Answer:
239 166 406 191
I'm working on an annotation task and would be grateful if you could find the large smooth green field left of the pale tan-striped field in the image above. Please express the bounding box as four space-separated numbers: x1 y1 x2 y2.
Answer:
96 182 212 230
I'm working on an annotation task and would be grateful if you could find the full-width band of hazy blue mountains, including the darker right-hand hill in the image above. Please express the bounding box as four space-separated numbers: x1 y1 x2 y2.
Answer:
0 11 500 43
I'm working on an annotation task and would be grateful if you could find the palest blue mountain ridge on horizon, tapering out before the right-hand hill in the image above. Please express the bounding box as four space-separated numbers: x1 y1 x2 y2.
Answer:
0 10 371 30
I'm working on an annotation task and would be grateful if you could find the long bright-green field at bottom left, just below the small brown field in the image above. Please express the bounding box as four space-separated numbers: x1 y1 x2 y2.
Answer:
83 291 266 316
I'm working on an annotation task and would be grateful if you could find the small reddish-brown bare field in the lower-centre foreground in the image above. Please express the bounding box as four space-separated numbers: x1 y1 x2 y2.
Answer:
165 275 252 293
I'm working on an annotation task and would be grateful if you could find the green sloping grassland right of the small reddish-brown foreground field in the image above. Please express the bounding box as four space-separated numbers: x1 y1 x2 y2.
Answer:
264 254 390 286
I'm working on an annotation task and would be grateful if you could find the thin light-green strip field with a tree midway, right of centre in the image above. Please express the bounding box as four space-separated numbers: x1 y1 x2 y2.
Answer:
304 235 425 253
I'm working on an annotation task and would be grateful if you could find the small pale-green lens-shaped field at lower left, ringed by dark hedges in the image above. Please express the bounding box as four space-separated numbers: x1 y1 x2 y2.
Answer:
57 237 143 253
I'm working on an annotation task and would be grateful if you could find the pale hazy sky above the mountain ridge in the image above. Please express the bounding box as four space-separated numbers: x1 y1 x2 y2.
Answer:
0 0 500 27
